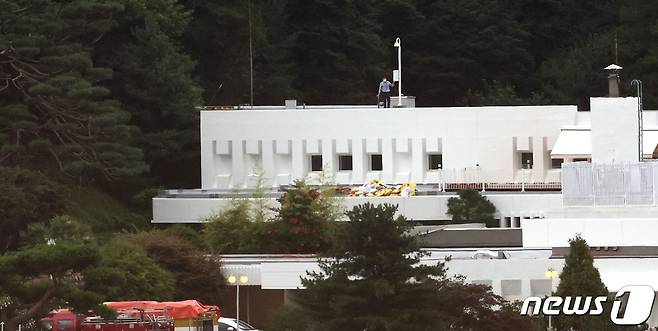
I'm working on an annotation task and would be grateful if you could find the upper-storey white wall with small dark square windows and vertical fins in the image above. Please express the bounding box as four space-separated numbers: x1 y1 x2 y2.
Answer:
201 106 582 188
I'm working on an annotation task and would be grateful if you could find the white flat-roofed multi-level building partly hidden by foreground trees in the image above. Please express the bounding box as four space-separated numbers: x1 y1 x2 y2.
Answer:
153 98 658 326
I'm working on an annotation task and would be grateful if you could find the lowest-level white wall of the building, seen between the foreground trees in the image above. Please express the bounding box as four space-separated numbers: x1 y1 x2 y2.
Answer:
222 255 658 327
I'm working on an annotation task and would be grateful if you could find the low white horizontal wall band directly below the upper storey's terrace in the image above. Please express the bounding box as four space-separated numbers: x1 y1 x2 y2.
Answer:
153 193 562 227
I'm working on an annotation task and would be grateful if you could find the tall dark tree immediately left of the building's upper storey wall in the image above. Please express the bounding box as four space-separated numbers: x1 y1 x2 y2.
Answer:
95 0 201 186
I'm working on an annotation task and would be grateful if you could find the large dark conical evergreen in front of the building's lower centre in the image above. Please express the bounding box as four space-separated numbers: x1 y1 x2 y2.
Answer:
298 203 530 331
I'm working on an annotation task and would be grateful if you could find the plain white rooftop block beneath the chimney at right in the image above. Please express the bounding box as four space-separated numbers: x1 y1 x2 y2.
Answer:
590 98 639 163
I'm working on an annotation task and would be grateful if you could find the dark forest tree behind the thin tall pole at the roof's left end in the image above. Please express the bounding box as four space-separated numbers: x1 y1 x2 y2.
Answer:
185 0 299 105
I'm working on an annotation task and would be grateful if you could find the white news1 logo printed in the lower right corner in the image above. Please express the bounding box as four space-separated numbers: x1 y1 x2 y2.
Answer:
521 285 656 325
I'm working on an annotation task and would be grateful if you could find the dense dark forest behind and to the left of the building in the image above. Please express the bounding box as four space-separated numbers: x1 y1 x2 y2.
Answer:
0 0 658 330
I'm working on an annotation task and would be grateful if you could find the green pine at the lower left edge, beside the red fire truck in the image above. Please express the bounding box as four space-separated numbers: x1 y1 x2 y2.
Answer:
0 217 104 330
